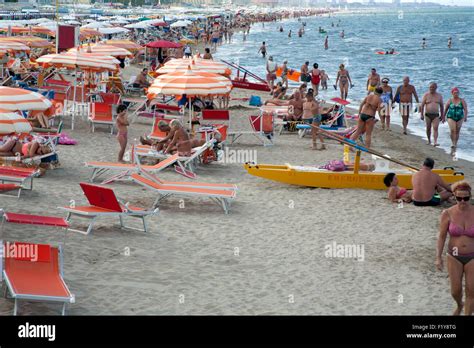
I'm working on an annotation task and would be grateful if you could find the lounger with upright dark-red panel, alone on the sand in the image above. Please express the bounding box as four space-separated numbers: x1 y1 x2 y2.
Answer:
59 183 159 235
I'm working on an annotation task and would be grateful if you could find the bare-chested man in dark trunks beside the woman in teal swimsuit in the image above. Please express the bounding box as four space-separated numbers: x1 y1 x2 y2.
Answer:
420 82 444 146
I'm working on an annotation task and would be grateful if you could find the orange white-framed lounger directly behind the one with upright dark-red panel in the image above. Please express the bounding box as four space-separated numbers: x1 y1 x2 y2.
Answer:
85 154 178 184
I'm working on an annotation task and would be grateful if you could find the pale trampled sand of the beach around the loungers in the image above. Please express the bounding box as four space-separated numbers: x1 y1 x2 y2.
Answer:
0 79 474 315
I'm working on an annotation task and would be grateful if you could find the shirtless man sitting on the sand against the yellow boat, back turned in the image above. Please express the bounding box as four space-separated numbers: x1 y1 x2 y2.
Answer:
411 158 453 207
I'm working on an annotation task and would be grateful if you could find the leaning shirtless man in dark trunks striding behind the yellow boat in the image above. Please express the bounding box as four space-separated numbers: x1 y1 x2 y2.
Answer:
351 87 383 148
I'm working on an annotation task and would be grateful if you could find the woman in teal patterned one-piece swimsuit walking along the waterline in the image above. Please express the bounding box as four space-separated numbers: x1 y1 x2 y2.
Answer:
444 87 467 156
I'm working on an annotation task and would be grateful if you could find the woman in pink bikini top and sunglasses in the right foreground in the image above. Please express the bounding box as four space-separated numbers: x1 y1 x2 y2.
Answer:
436 181 474 315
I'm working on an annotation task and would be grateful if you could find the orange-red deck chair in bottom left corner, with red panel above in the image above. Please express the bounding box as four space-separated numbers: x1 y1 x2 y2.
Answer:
0 211 75 315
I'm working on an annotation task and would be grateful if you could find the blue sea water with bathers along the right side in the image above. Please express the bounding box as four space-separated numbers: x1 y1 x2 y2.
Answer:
215 7 474 161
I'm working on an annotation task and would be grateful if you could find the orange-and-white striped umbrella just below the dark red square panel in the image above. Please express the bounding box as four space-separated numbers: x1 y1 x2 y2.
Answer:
36 50 120 72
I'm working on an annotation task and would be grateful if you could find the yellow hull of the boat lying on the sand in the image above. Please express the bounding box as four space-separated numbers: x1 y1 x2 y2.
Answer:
244 164 464 190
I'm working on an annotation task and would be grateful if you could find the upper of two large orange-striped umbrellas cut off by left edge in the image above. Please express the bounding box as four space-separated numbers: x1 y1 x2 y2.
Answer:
0 86 53 111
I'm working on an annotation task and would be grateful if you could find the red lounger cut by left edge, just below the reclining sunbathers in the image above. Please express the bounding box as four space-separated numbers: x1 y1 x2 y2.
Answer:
0 166 40 198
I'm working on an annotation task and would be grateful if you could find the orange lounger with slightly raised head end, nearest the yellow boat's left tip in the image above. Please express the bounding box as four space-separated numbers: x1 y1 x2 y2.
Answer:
131 171 237 214
